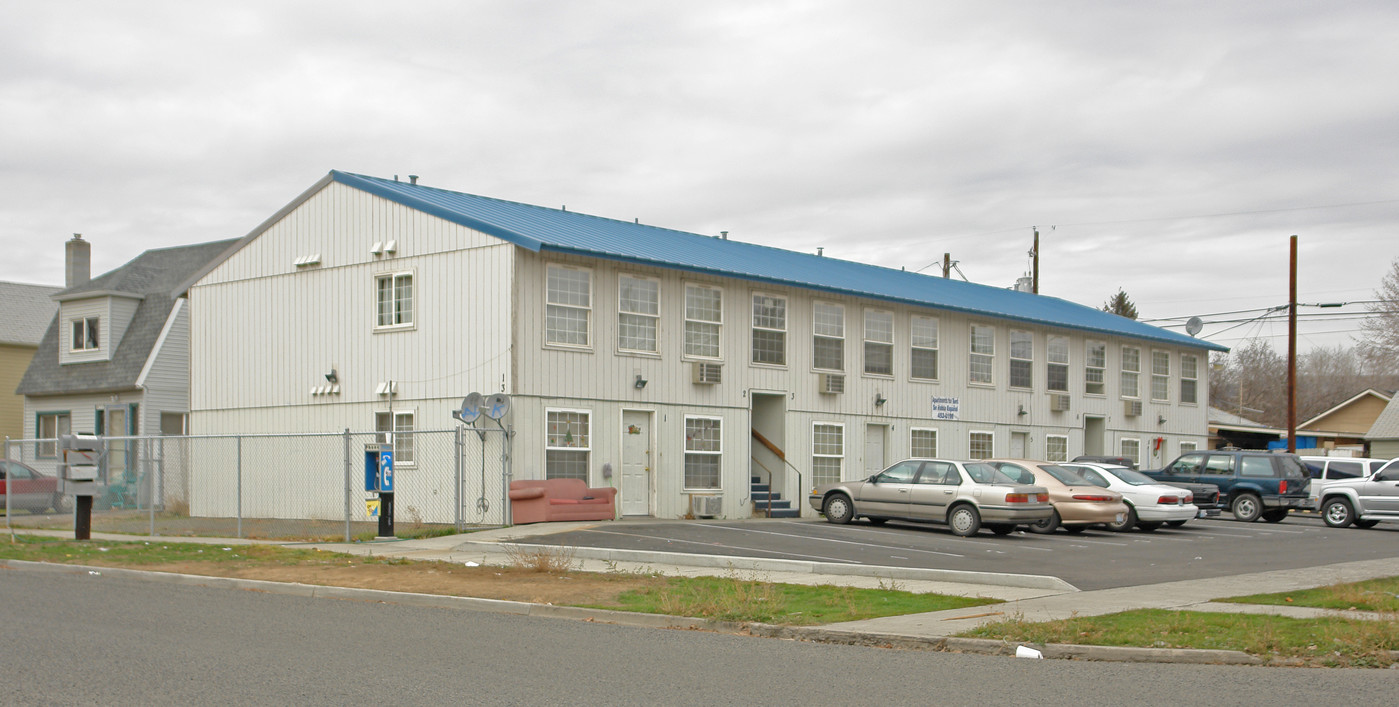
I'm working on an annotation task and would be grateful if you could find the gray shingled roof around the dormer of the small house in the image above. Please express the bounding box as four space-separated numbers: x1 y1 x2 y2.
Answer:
15 241 236 395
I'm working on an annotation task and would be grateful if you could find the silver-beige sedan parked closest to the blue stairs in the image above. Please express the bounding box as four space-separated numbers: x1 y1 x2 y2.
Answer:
807 459 1053 536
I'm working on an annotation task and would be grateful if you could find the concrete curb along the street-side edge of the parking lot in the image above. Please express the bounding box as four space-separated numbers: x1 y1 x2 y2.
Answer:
464 542 1079 592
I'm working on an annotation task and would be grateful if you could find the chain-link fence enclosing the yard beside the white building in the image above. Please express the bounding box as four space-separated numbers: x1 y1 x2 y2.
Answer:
4 428 511 540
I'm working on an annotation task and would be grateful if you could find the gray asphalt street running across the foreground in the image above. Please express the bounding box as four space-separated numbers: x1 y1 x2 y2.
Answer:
0 570 1395 707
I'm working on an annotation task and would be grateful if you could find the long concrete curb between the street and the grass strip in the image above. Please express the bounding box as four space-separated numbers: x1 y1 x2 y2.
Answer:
0 560 1281 665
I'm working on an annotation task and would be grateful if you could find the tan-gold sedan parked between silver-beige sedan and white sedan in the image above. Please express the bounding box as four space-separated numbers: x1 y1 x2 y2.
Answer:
986 459 1128 533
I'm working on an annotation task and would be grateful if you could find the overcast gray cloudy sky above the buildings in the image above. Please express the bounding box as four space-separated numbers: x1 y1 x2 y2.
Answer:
0 0 1399 350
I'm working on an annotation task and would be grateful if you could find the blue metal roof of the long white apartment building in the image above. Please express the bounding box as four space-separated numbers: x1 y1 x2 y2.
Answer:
330 171 1228 351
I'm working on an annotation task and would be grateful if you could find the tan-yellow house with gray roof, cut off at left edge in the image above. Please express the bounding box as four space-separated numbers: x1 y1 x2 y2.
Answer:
0 283 60 440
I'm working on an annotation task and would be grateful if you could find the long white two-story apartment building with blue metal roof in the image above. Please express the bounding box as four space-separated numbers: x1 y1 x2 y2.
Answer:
176 172 1224 522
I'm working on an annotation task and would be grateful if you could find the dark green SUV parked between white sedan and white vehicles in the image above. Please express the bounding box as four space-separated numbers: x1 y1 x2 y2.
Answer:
1142 449 1311 522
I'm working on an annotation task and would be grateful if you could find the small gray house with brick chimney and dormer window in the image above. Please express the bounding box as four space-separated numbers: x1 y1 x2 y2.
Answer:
18 235 232 479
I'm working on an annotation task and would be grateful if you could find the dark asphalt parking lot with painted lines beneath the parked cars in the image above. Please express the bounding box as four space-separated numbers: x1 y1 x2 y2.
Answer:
519 514 1399 589
